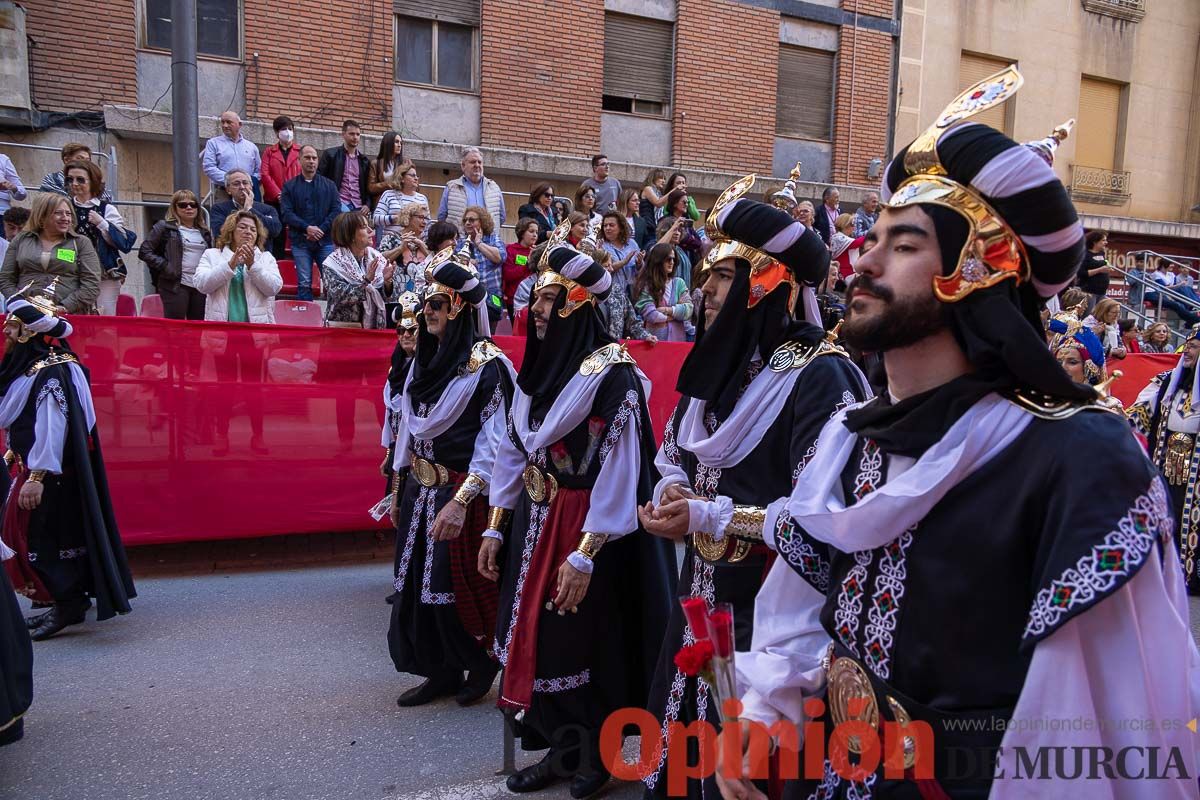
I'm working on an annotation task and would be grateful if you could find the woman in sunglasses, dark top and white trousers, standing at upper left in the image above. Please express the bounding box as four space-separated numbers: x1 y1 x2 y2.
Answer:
62 161 137 317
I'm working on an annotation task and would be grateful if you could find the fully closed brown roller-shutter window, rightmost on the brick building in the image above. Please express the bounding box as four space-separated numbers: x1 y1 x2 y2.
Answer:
775 44 834 142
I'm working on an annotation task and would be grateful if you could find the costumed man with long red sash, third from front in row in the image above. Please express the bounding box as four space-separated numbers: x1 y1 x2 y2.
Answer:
479 222 677 798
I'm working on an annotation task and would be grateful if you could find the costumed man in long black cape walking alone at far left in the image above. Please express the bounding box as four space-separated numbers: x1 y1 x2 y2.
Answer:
0 283 136 642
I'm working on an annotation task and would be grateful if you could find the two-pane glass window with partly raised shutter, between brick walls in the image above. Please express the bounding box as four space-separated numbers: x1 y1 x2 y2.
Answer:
392 0 480 91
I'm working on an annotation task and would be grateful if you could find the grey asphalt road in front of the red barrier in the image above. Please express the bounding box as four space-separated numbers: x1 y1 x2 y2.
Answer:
0 560 641 800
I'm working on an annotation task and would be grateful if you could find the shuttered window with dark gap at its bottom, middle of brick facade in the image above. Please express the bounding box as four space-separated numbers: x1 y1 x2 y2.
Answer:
601 13 674 116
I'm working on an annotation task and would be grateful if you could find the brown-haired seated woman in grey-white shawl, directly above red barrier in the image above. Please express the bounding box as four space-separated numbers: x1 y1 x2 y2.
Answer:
320 211 386 330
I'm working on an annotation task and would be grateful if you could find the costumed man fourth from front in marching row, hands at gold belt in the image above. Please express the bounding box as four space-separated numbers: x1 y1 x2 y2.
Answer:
388 248 515 706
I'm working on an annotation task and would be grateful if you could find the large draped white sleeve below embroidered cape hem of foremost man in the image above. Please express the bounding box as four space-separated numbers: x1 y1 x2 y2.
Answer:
988 545 1200 800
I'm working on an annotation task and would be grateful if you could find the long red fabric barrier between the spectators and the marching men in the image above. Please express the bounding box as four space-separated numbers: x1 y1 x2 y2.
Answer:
71 317 689 545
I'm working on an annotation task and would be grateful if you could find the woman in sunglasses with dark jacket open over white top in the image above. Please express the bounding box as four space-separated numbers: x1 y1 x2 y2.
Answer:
138 188 212 320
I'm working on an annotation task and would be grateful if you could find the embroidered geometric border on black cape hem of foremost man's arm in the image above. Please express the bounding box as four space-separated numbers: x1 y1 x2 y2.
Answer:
1024 477 1174 637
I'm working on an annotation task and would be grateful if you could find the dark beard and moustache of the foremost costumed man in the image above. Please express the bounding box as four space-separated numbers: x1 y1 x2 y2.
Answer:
841 275 950 353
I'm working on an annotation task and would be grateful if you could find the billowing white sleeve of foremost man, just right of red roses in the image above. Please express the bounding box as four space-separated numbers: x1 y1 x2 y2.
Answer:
734 559 829 730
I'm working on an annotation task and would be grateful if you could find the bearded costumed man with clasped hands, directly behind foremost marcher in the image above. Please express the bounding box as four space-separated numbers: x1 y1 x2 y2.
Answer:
640 175 870 799
